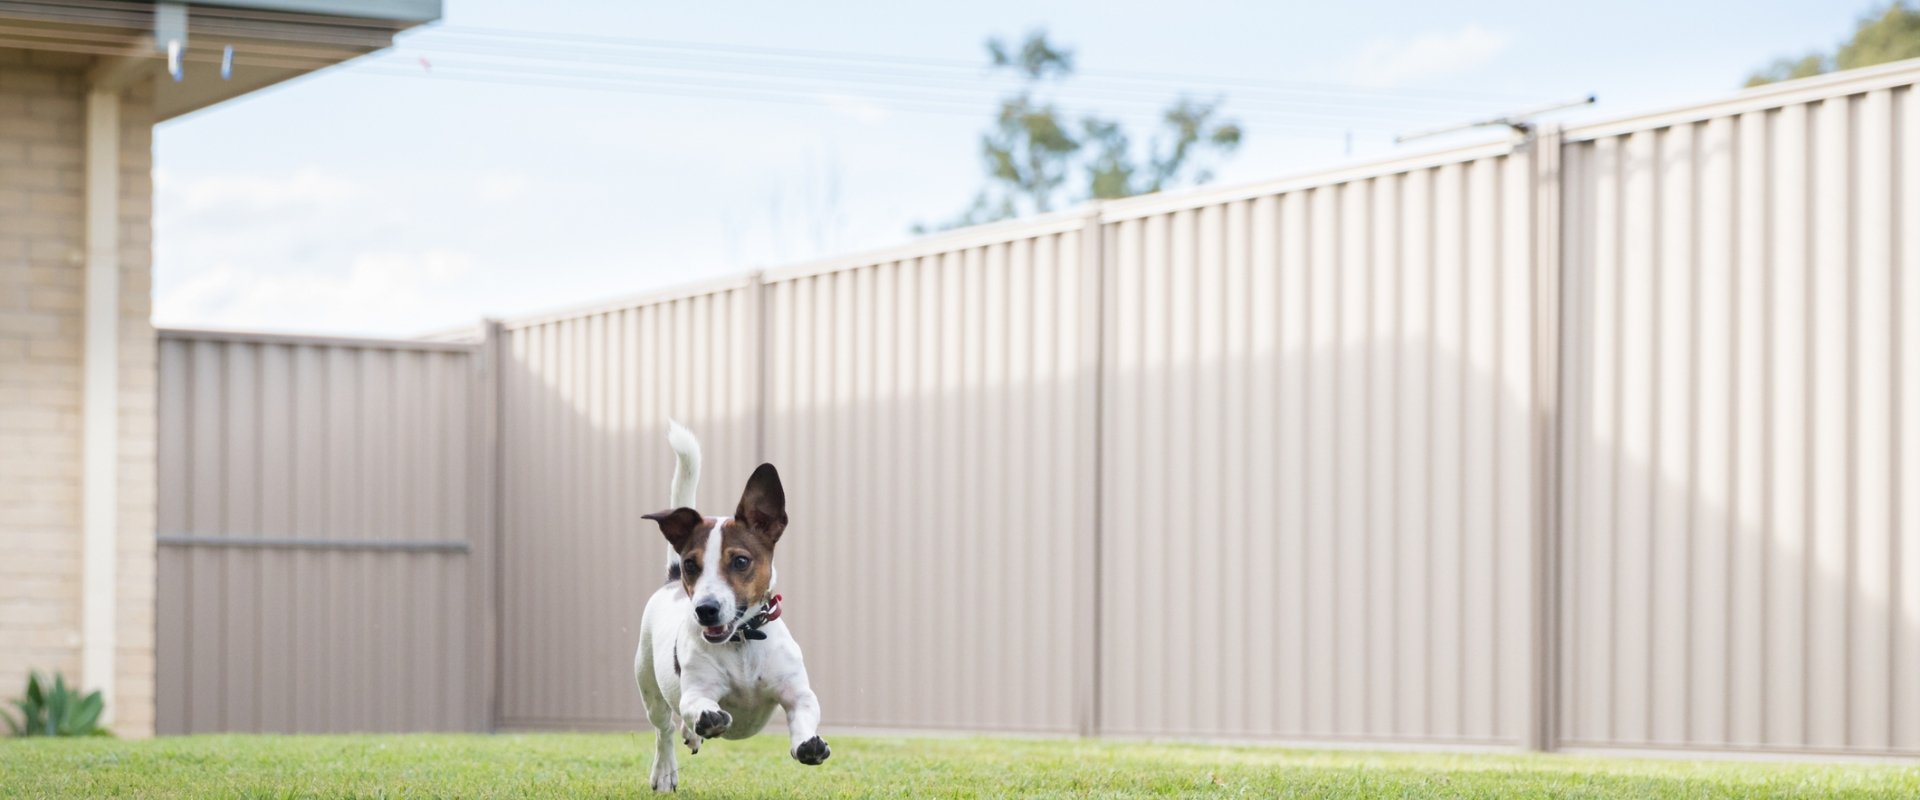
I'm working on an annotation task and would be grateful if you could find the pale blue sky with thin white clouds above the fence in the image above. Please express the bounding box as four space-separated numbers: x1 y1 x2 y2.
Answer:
154 0 1868 336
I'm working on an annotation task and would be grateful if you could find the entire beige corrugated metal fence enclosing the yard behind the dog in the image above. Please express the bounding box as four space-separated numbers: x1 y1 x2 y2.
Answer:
161 63 1920 756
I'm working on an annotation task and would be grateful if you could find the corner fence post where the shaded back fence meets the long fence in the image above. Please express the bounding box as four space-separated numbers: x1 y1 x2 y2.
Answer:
468 318 507 731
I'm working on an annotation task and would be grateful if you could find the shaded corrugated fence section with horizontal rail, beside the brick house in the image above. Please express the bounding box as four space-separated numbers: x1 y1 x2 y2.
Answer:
157 330 490 733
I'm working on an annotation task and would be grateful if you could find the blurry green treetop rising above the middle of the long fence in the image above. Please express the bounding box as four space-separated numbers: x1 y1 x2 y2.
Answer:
914 31 1242 232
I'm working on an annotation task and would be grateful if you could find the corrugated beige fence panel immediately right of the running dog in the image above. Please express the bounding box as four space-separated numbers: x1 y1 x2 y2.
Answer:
764 226 1098 731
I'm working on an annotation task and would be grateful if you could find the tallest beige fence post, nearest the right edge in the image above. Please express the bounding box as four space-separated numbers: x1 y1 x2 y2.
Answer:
1524 125 1567 750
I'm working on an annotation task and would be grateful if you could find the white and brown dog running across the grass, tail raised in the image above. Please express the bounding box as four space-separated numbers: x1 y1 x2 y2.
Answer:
634 420 829 792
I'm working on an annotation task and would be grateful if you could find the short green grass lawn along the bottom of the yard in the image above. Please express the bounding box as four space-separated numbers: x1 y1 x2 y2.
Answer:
0 733 1920 798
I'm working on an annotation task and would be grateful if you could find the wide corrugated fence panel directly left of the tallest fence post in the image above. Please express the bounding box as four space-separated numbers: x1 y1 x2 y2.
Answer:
1100 146 1534 744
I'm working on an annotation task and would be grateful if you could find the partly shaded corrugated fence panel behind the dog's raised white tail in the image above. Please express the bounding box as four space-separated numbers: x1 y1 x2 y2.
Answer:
499 284 760 729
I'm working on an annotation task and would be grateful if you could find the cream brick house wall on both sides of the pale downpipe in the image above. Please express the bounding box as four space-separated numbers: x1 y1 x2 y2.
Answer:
0 50 156 735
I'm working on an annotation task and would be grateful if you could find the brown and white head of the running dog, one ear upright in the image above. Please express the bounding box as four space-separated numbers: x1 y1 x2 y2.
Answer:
647 464 787 645
